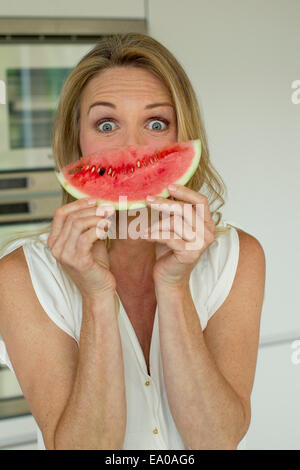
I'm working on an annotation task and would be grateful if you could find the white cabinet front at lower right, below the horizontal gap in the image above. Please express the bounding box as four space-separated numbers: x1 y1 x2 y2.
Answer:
246 344 300 450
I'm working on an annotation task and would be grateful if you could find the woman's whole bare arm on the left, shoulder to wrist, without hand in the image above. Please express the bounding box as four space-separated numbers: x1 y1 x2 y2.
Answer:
0 247 126 449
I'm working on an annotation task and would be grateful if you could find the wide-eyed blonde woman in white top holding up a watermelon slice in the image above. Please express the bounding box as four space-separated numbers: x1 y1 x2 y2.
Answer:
0 33 265 449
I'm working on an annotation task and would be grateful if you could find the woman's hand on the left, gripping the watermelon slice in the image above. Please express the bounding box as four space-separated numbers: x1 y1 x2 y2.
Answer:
48 198 116 298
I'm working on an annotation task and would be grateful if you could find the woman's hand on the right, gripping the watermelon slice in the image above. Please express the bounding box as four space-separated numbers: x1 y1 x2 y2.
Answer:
142 185 215 286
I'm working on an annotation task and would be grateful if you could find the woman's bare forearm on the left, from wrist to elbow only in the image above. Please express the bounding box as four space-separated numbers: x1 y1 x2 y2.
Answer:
55 294 126 449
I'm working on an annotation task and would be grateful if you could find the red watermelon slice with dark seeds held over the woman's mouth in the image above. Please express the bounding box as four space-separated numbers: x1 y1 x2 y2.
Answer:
55 140 202 210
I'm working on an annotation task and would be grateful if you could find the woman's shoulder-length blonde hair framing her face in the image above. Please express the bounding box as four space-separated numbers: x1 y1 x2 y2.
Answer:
0 33 230 276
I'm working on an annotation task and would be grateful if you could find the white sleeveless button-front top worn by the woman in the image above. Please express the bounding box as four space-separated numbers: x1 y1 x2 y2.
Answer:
0 221 246 450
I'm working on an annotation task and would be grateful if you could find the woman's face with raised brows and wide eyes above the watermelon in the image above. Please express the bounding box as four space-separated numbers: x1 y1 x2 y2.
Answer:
80 67 177 156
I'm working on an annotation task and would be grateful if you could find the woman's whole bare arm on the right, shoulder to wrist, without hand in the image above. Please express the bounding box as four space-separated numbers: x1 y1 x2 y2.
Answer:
156 231 266 449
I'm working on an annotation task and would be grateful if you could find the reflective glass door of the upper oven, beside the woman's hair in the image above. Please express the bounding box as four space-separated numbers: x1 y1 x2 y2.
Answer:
0 43 95 171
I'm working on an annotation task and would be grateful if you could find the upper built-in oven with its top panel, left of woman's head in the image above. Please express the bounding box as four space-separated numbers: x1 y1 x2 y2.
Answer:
0 17 146 171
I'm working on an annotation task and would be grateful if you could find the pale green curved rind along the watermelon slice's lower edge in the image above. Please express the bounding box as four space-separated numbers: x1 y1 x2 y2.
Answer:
55 139 202 210
